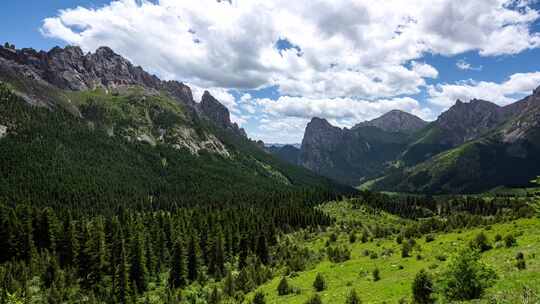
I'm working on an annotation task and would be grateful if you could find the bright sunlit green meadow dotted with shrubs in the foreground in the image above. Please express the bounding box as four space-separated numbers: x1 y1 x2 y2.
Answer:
251 202 540 304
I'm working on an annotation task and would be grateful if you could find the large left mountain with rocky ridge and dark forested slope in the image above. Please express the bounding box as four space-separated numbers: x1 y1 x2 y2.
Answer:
0 47 350 210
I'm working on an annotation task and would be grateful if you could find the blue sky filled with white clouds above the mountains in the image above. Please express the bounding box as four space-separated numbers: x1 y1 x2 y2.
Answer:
0 0 540 143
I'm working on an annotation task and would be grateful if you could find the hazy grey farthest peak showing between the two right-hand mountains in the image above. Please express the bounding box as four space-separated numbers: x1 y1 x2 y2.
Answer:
353 110 428 133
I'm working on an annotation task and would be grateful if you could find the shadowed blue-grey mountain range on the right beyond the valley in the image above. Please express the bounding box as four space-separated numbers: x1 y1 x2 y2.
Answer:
274 88 540 193
